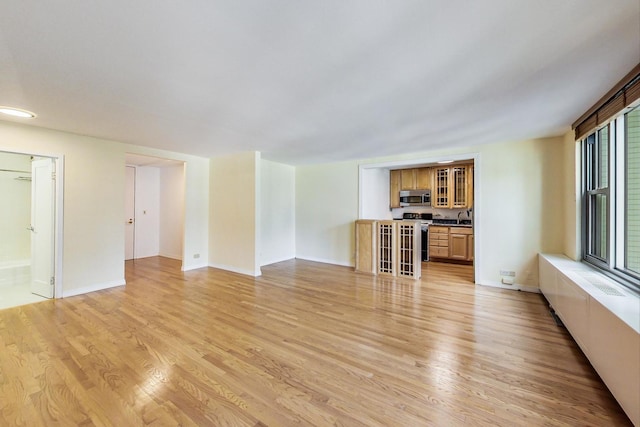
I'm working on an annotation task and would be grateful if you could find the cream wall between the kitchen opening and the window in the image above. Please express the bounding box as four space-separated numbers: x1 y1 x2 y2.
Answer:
475 138 564 288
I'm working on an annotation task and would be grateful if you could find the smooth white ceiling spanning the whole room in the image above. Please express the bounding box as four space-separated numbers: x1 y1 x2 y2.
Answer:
0 0 640 164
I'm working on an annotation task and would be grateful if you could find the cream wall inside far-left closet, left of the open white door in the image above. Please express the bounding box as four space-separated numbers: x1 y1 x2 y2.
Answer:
0 152 31 265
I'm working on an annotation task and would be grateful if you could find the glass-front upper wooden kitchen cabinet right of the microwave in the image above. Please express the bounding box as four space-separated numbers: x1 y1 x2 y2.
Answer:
432 165 473 209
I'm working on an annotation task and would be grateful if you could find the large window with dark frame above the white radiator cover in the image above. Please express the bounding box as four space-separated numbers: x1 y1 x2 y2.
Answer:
583 106 640 292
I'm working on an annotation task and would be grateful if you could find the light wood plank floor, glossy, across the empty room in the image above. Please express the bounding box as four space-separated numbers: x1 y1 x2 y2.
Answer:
0 258 630 426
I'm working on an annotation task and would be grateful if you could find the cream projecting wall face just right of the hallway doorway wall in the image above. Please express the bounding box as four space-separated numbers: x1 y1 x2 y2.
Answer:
209 152 261 276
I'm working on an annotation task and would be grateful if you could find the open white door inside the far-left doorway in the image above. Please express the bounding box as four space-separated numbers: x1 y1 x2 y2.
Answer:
30 159 55 298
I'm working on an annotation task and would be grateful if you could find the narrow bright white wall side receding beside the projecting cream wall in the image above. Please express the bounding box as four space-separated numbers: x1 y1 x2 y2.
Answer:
260 160 296 265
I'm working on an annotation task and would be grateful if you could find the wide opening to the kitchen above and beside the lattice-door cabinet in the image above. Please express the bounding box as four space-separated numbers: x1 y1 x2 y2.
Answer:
358 153 482 283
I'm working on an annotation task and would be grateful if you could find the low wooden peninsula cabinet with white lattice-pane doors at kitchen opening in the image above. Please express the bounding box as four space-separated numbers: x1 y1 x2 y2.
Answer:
355 220 422 279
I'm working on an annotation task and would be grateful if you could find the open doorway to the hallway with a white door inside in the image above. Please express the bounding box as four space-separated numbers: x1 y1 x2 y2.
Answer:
124 154 185 268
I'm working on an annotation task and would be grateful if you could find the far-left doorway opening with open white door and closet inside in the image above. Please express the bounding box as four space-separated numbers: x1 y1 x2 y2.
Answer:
0 151 62 308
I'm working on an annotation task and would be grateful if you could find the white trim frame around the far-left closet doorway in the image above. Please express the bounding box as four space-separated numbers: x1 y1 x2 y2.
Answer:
0 146 64 299
